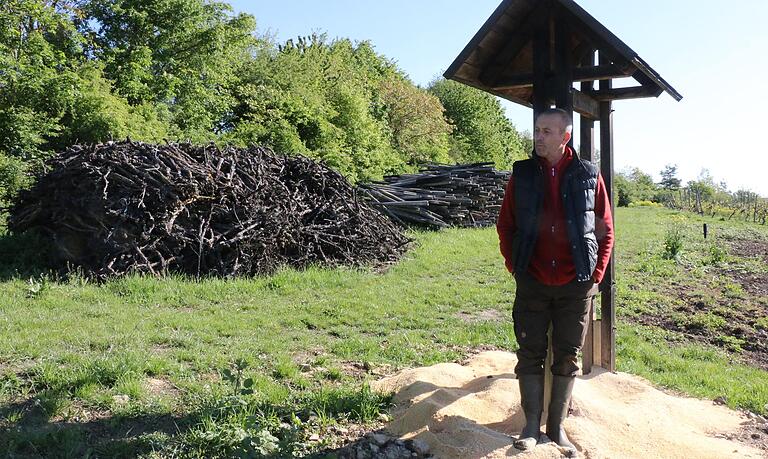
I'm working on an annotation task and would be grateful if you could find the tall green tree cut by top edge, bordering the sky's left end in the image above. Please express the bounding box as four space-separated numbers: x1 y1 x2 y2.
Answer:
77 0 255 141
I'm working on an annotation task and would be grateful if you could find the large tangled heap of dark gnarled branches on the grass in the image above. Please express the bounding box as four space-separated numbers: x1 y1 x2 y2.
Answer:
8 141 409 277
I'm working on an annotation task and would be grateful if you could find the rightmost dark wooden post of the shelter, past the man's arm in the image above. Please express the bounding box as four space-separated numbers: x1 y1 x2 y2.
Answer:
600 53 616 371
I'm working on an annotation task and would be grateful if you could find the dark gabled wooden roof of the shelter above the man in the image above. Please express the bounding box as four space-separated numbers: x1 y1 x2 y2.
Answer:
444 0 683 106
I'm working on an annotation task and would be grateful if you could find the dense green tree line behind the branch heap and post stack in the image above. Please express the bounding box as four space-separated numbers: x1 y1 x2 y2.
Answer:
0 0 530 204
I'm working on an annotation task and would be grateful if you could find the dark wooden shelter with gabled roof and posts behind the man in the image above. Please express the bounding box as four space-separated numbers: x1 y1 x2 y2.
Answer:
444 0 682 373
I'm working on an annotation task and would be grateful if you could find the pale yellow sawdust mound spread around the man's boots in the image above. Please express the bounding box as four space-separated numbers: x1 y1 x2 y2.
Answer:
373 351 763 459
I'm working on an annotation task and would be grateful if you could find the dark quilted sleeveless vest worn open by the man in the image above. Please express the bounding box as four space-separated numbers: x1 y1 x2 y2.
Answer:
512 156 598 281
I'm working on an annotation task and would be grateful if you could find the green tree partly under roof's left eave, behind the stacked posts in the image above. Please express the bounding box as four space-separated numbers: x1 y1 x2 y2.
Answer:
429 79 529 169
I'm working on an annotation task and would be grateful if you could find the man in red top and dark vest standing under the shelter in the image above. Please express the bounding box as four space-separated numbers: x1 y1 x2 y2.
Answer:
496 109 613 450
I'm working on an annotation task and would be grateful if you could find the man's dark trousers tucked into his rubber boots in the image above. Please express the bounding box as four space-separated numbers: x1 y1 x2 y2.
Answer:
512 273 598 376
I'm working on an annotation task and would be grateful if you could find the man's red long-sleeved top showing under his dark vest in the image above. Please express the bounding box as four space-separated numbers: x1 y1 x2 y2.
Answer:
496 148 614 285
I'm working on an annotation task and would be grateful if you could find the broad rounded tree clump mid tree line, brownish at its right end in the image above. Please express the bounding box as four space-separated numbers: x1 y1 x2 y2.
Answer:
224 34 436 181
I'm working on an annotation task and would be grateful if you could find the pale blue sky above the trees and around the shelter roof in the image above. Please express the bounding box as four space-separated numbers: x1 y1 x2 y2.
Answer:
229 0 768 196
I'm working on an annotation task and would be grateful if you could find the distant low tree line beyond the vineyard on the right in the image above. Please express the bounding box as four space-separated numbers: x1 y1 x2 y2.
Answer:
613 165 768 225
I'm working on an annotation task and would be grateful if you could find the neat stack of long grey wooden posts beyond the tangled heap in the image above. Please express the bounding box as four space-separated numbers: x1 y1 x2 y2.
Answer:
360 163 511 228
